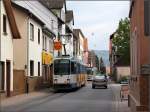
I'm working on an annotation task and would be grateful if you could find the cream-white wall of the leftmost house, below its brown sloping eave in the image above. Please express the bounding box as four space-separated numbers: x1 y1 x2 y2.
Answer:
0 1 13 91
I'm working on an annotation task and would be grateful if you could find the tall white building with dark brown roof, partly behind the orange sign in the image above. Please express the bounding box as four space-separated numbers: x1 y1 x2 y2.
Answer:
40 0 66 57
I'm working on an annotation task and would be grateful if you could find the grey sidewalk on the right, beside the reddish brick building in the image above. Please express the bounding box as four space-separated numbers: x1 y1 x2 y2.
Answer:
111 84 130 112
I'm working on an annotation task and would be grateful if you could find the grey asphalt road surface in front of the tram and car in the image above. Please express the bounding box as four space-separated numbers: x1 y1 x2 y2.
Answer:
1 84 115 112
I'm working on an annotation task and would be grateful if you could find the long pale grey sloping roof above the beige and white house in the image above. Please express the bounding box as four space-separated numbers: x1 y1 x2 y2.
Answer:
13 0 58 35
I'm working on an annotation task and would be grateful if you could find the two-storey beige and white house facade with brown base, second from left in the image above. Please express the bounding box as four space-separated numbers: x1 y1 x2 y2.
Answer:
13 2 44 94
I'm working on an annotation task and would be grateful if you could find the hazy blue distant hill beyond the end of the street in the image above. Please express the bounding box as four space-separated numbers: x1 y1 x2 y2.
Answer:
93 50 110 66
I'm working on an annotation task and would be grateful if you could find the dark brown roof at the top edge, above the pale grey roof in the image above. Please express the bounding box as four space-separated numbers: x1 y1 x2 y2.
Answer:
39 0 65 9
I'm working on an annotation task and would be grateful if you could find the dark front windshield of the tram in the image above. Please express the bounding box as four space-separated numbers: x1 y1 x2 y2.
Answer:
54 59 70 75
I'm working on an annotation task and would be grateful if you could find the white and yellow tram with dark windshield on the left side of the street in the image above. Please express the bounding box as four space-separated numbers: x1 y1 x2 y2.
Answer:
53 58 87 89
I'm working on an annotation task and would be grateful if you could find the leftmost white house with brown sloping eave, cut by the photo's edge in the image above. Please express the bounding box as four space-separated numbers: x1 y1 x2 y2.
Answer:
0 0 20 96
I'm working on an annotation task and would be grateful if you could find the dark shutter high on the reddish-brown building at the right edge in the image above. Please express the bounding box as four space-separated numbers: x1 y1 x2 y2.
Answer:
144 0 150 36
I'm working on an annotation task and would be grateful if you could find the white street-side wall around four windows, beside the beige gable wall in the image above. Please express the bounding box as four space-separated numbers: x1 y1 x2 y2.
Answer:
28 19 42 76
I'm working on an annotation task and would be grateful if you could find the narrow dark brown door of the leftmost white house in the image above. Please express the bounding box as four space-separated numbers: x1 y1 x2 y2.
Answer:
6 61 11 97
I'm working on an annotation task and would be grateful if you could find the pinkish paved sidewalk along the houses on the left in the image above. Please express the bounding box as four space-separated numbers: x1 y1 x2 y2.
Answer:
0 88 54 107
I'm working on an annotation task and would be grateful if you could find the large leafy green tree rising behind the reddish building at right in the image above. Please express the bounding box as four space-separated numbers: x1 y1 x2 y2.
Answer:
112 18 130 65
